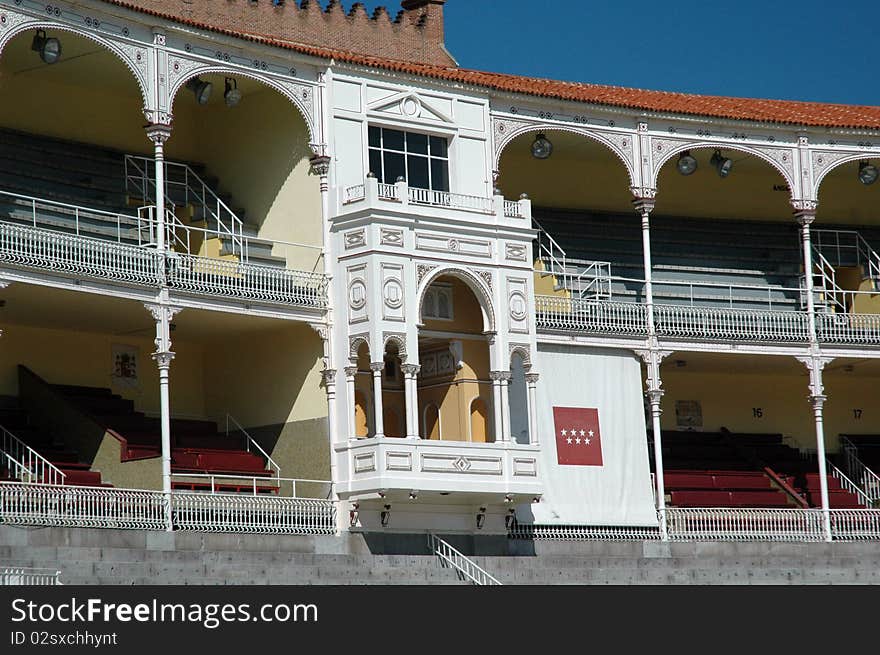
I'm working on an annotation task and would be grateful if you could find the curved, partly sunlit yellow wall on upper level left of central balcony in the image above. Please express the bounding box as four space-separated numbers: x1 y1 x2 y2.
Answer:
192 87 322 270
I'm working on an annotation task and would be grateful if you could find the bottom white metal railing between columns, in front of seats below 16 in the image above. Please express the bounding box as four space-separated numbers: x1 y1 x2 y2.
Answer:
665 507 825 541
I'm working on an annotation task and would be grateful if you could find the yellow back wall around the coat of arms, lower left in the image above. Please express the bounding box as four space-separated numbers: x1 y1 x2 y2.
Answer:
0 324 205 418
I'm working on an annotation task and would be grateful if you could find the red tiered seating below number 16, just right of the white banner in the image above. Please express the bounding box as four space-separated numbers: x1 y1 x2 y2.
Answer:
663 432 795 508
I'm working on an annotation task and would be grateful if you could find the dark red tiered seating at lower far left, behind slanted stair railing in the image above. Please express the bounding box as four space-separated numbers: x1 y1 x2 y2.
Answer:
0 396 113 487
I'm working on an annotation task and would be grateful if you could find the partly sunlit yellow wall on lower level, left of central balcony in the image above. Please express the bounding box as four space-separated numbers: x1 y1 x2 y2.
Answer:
204 323 327 428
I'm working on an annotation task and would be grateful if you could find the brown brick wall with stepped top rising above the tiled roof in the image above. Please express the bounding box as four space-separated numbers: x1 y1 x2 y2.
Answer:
108 0 456 66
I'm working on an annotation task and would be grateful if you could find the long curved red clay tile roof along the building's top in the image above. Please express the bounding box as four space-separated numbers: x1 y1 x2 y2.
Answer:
104 0 880 129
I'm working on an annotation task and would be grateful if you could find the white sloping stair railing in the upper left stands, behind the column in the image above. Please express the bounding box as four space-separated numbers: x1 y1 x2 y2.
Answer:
125 155 248 262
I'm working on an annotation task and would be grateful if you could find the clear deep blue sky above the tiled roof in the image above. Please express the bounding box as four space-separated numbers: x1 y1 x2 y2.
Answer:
354 0 880 105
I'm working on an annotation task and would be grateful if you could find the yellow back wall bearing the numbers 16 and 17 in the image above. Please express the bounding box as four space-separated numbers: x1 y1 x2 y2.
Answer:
661 367 880 452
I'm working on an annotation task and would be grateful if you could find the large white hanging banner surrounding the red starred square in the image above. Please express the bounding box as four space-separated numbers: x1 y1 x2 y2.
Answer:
517 344 657 526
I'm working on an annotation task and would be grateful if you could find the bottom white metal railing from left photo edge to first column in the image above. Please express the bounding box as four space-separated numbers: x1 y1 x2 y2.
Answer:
0 482 167 530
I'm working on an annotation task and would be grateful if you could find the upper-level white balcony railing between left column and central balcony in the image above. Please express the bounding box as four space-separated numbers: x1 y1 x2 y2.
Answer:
167 253 327 308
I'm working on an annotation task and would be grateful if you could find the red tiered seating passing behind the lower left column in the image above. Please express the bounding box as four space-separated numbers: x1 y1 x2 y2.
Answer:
53 385 278 493
